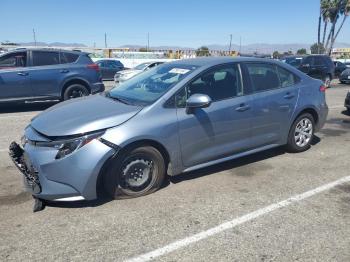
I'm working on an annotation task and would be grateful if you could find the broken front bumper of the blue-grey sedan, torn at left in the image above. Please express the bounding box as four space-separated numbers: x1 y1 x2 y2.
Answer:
9 130 116 201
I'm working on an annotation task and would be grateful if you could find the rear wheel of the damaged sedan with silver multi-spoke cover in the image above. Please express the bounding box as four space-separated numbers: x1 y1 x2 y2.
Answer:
287 113 315 153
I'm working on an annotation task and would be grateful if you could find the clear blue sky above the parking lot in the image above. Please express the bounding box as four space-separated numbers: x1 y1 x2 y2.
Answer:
0 0 350 48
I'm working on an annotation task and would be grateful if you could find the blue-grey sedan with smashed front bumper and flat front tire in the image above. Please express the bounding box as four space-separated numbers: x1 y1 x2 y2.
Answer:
10 57 328 211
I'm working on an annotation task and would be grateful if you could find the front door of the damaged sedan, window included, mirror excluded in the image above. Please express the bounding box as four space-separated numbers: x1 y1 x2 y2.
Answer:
177 64 252 167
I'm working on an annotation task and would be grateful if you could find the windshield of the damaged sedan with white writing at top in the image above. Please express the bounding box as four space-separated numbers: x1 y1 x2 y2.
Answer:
107 64 198 105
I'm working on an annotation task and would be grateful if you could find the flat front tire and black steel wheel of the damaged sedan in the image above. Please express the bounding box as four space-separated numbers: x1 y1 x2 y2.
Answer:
104 146 166 199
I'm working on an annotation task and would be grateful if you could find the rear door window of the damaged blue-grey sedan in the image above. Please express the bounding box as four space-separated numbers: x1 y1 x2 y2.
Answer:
246 63 280 92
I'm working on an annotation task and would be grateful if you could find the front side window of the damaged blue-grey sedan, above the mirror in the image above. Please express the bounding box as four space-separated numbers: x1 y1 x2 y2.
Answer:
187 64 243 101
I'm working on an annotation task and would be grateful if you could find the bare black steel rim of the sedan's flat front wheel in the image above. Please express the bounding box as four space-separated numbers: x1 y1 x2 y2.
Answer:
121 158 153 191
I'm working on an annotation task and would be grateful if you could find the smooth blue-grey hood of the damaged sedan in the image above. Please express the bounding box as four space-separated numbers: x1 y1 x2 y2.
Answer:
31 94 142 137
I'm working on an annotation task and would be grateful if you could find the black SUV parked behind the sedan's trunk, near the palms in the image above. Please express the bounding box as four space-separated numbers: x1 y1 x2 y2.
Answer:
299 55 335 87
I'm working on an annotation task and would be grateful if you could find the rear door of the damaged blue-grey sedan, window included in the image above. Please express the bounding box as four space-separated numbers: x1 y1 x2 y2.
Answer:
245 63 299 147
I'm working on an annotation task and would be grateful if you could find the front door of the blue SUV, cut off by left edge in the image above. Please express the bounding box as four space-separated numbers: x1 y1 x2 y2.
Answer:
0 51 32 102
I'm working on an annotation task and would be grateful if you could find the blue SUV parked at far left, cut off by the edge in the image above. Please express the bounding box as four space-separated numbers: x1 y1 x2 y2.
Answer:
0 49 104 103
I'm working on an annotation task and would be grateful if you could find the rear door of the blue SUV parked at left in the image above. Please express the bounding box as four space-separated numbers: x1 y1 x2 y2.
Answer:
29 50 63 99
